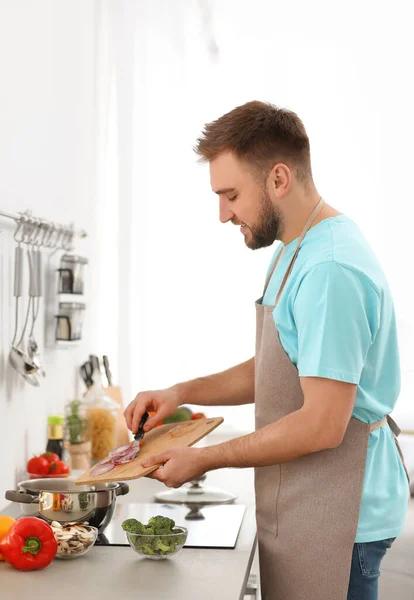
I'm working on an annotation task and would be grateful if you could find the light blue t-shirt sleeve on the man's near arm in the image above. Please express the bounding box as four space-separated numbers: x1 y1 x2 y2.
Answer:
293 261 380 383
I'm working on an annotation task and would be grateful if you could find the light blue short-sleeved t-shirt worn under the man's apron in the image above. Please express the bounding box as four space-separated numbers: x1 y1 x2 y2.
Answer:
263 215 409 543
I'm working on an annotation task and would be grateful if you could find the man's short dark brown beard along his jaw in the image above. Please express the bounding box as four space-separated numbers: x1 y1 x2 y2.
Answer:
246 188 284 250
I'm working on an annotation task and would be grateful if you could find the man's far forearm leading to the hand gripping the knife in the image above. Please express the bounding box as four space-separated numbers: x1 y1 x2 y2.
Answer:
174 358 254 406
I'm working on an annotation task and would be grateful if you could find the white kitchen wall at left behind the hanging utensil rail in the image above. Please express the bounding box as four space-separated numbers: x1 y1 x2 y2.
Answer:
0 0 96 509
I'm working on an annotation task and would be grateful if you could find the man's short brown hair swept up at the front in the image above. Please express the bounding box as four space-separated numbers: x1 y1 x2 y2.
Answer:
194 100 312 182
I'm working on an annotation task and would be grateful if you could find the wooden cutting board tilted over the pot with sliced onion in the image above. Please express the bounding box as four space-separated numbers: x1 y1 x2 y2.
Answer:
75 417 224 485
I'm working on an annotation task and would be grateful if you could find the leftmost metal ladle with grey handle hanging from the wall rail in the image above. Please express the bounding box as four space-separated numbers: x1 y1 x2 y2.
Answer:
9 244 38 378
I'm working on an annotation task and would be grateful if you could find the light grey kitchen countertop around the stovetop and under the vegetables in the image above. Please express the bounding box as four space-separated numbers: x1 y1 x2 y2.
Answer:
0 432 256 600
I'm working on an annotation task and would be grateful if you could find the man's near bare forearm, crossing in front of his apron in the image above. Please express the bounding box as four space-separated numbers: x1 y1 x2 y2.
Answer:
200 409 335 472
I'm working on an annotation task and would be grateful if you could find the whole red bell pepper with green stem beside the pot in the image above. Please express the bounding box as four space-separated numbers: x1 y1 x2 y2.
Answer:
0 517 58 571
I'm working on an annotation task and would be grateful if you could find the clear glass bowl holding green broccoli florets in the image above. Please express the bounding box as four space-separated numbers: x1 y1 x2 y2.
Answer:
125 527 188 560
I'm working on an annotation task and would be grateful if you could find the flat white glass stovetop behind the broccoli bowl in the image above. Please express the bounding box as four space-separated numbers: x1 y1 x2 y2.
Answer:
96 503 246 549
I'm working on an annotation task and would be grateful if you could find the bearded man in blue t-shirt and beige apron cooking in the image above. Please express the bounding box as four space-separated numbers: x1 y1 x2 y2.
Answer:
125 102 409 600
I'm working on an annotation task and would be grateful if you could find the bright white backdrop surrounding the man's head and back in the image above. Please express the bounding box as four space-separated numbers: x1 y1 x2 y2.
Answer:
101 0 414 442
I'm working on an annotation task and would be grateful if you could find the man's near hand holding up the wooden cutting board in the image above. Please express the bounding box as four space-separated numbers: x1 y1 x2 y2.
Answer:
141 446 207 488
